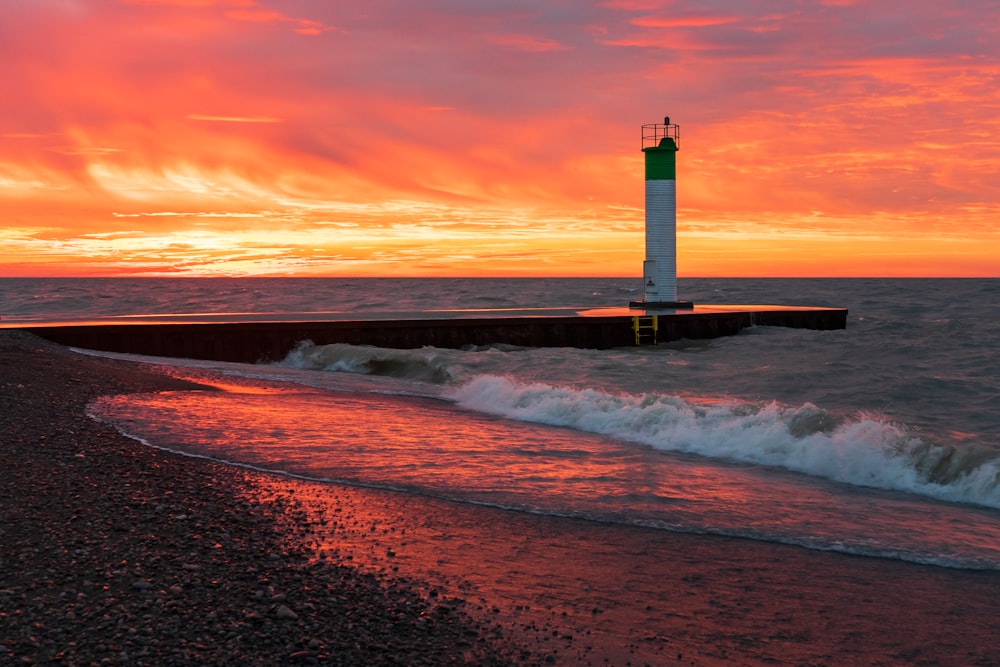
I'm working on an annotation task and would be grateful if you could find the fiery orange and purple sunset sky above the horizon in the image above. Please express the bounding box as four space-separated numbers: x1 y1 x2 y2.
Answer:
0 0 1000 276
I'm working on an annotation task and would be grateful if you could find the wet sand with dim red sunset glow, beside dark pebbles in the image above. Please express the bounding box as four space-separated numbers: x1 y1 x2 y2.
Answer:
248 477 997 665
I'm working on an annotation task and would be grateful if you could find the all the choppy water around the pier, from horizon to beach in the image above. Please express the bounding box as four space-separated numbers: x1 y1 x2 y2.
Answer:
0 279 1000 569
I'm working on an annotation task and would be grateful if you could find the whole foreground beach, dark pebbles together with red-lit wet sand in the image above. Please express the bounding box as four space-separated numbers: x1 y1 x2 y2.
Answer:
0 332 1000 665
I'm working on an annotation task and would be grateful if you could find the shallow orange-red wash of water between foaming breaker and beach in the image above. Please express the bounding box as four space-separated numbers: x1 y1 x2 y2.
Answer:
93 374 1000 568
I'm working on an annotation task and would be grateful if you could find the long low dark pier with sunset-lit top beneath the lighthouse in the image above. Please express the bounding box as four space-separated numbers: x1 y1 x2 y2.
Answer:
9 305 847 363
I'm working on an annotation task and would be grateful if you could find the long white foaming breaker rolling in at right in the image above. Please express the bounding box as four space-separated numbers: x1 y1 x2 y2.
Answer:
449 376 1000 508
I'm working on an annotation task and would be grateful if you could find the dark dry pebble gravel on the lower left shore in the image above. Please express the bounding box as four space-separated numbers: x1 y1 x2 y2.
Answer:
0 330 551 666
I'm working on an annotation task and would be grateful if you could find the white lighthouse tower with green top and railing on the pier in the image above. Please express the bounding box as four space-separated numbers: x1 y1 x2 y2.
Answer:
629 116 694 309
